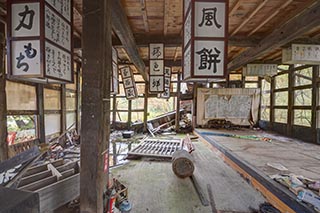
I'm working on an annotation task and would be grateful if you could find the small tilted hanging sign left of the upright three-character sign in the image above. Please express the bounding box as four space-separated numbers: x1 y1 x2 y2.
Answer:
120 66 138 100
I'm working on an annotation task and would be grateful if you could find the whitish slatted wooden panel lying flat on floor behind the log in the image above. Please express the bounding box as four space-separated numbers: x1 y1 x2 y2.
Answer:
128 138 182 158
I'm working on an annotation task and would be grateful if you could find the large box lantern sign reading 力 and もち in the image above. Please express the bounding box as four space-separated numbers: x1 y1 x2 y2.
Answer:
7 0 74 83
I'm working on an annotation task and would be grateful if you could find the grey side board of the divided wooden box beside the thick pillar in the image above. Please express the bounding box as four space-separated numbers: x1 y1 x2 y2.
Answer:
36 174 80 212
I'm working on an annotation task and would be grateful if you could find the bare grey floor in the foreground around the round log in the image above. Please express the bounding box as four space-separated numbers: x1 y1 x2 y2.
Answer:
111 137 265 213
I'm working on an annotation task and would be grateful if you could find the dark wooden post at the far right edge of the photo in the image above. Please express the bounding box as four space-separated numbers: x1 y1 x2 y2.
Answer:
311 65 319 143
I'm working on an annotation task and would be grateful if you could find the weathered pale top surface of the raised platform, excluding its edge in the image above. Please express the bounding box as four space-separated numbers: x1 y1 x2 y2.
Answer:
198 129 320 180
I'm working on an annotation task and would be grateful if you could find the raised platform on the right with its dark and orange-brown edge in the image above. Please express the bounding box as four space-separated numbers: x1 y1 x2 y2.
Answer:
195 129 320 213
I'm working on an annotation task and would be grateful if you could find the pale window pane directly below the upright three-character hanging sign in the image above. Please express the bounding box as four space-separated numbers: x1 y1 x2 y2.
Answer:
148 97 174 119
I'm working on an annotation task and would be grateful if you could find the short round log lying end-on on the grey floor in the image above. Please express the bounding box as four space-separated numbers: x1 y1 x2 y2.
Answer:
172 150 194 178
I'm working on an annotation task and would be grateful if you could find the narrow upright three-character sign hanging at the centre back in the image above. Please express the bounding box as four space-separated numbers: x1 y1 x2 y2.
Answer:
149 43 164 93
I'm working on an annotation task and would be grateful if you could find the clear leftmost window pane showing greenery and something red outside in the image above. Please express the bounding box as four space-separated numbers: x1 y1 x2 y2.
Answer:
7 115 37 145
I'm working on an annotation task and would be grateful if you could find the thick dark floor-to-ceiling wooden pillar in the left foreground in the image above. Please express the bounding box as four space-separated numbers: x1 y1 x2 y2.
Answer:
80 0 112 213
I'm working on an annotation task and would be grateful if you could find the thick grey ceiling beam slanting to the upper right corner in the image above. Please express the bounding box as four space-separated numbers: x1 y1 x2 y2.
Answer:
228 1 320 71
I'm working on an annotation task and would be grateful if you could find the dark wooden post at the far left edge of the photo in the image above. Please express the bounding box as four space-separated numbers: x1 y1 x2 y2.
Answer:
0 32 8 162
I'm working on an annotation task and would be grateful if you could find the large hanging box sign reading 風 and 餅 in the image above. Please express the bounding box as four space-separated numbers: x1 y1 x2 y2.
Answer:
183 0 228 81
